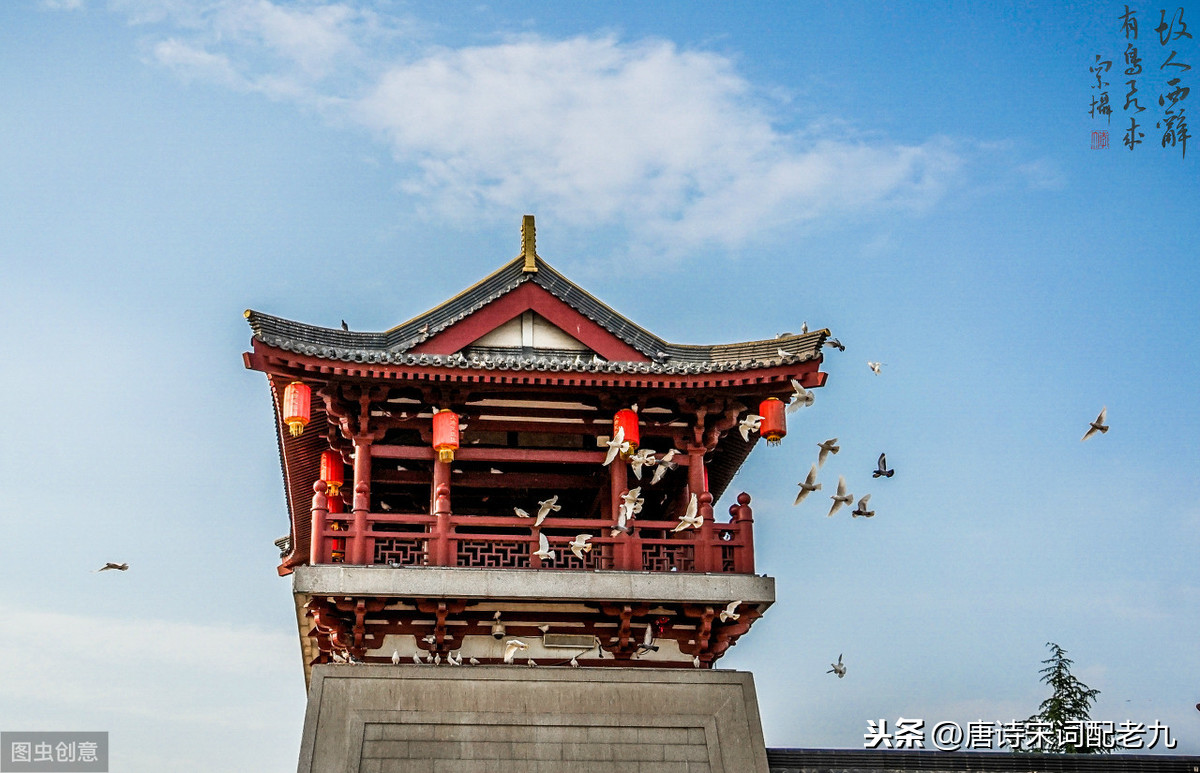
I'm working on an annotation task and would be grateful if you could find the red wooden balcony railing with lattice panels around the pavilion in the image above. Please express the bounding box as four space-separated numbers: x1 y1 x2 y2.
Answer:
310 481 754 574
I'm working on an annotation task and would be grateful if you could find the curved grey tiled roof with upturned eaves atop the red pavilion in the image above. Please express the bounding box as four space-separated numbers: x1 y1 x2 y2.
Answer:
246 258 829 374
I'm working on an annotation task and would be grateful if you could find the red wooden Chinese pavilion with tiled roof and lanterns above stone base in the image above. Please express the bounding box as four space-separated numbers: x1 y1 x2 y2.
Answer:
245 216 828 769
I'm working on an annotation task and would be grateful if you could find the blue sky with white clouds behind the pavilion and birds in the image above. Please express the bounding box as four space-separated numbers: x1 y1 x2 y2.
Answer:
0 0 1200 771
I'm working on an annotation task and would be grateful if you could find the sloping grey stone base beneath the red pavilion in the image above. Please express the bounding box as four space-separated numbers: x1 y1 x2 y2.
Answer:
298 664 768 773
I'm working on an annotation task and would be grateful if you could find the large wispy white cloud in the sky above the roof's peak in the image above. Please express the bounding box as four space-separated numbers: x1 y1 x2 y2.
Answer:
119 0 962 252
